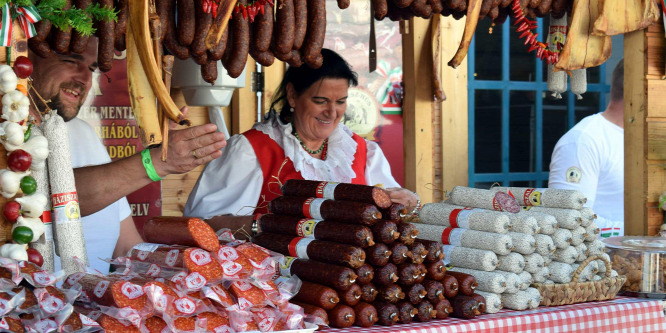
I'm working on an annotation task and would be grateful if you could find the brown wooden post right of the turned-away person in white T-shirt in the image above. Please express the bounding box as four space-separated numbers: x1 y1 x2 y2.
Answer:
624 31 648 236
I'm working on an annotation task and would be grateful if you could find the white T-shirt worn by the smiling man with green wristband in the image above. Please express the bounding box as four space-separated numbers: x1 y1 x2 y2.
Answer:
55 118 132 274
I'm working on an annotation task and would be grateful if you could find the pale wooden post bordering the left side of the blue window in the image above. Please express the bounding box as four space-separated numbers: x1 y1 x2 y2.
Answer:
441 16 469 191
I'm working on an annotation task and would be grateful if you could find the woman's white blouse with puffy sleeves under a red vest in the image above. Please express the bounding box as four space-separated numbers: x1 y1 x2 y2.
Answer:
184 114 400 219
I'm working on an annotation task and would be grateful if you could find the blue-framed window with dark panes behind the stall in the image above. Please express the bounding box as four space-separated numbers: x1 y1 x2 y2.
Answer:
468 18 610 188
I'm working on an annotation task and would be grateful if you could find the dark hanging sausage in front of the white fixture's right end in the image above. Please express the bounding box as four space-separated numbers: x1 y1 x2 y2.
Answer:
222 0 250 78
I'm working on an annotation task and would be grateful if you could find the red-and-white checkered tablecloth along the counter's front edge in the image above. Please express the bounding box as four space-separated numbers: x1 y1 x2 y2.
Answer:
324 297 666 333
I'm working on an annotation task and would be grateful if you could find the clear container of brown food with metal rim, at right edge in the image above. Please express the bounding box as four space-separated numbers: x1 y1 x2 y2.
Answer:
603 236 666 299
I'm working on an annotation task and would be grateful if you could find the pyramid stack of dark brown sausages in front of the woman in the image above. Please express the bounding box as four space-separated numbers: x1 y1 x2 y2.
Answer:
252 180 485 328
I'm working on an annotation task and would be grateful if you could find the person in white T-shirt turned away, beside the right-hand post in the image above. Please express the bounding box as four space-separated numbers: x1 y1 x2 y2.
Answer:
548 60 624 237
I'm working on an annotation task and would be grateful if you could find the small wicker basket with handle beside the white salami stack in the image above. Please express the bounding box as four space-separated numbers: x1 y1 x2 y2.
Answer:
532 256 627 306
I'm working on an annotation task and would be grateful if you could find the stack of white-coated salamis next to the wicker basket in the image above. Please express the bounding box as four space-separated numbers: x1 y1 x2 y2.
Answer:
414 186 617 311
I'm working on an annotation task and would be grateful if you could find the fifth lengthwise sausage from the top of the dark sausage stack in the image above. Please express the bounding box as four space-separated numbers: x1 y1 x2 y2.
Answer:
280 258 356 290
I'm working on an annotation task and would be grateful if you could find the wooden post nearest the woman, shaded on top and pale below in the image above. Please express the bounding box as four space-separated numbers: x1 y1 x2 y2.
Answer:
402 18 434 203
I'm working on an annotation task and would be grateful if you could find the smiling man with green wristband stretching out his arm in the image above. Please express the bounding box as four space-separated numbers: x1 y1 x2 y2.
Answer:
30 38 226 272
